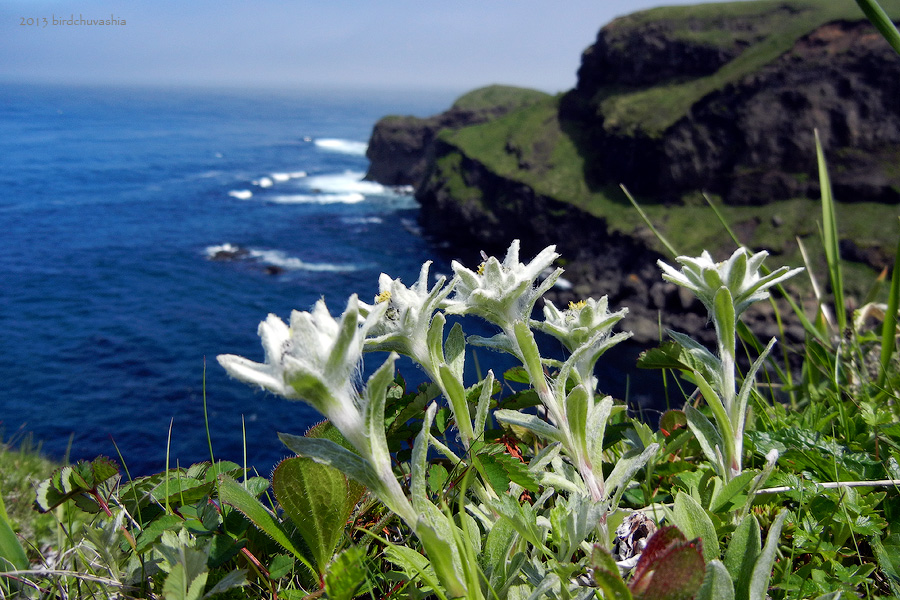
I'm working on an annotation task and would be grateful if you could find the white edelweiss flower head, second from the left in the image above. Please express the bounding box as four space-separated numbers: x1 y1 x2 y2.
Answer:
360 261 455 363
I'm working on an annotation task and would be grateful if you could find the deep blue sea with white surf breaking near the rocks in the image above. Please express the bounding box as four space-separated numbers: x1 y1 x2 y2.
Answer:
0 84 660 475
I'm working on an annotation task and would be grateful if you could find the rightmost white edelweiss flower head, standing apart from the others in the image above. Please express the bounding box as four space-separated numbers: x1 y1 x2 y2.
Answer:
657 248 803 318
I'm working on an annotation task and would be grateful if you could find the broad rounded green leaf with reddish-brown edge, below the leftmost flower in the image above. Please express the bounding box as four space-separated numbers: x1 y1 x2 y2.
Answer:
272 457 359 575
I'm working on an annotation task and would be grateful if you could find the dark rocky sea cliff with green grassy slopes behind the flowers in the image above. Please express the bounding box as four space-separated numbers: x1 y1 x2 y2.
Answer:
369 0 900 341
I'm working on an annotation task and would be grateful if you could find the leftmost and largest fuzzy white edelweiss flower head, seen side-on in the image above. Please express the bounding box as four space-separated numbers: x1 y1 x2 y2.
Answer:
218 295 385 450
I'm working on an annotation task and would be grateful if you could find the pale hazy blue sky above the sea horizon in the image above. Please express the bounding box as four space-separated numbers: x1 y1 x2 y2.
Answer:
0 0 740 93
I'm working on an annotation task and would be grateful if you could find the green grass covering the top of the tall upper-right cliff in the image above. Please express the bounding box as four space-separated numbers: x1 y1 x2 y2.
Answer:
593 0 900 137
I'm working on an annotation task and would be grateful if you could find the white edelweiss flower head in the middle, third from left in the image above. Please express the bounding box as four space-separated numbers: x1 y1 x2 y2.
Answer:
446 240 562 330
